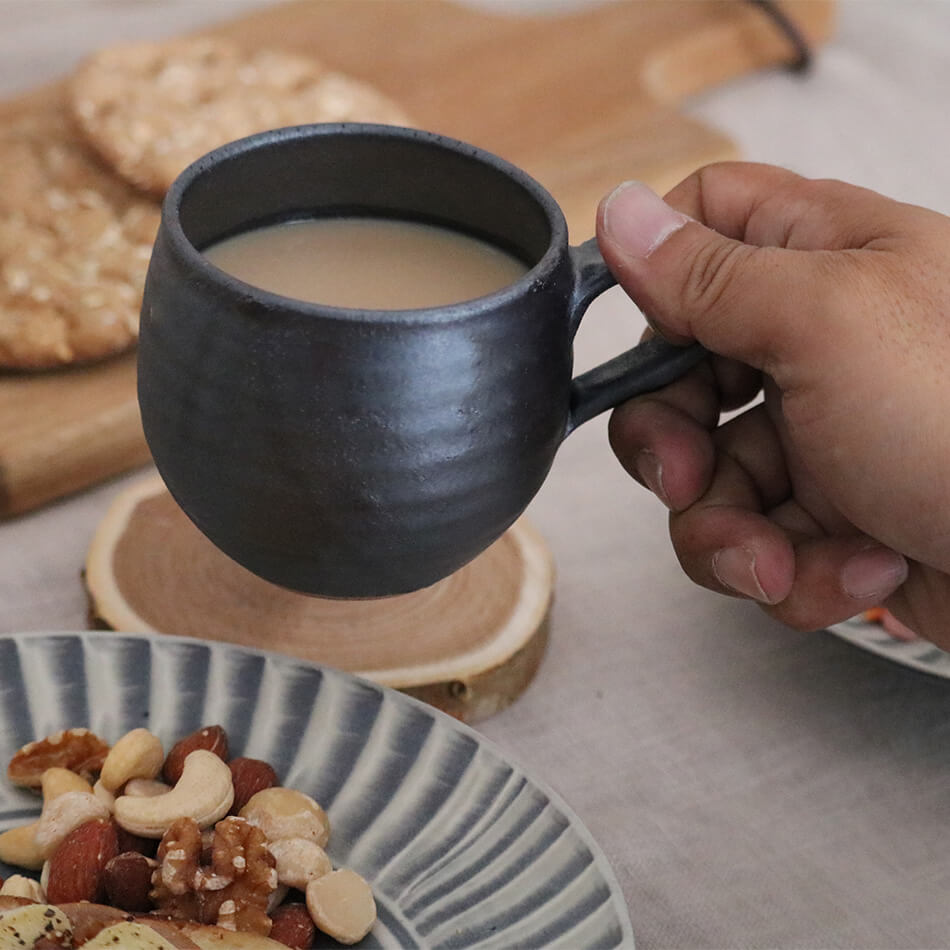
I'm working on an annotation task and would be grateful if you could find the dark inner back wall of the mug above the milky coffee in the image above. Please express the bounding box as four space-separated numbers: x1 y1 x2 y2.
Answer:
172 123 567 282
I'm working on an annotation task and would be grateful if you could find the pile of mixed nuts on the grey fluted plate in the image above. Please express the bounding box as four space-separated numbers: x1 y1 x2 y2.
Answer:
0 726 376 948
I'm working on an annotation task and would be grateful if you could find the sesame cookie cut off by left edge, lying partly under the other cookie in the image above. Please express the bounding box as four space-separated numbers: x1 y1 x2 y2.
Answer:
0 107 159 369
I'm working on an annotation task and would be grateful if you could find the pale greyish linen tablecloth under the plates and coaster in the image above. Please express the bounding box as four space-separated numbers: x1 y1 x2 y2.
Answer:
0 0 950 950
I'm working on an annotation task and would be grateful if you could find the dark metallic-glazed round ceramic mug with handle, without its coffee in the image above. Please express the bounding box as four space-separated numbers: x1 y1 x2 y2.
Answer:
138 123 704 597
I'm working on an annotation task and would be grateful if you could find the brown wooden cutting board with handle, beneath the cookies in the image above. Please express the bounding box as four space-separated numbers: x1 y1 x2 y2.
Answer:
0 0 833 516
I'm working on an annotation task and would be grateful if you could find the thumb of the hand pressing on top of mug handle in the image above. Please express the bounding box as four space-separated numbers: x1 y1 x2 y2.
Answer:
597 182 832 370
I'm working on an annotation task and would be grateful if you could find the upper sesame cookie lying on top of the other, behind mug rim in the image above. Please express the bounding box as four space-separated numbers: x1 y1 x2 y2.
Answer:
70 38 408 195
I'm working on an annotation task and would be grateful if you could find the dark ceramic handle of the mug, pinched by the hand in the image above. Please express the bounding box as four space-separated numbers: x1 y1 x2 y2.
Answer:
564 238 707 436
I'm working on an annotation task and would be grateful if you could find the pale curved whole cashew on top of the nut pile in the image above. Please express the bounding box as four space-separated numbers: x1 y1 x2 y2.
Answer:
115 749 234 838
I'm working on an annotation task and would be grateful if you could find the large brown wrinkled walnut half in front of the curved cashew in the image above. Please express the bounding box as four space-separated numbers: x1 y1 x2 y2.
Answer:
152 817 277 936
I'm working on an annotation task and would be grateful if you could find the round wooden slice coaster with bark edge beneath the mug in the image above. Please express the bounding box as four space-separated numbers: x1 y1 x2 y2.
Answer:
84 476 554 722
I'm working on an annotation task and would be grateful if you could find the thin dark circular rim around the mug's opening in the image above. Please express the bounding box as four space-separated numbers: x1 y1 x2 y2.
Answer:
160 122 568 323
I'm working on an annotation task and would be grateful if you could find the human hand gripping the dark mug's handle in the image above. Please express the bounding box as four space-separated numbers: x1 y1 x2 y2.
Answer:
598 163 950 649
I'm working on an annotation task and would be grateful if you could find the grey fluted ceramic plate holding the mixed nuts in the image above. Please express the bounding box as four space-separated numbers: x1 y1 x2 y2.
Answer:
0 633 633 950
